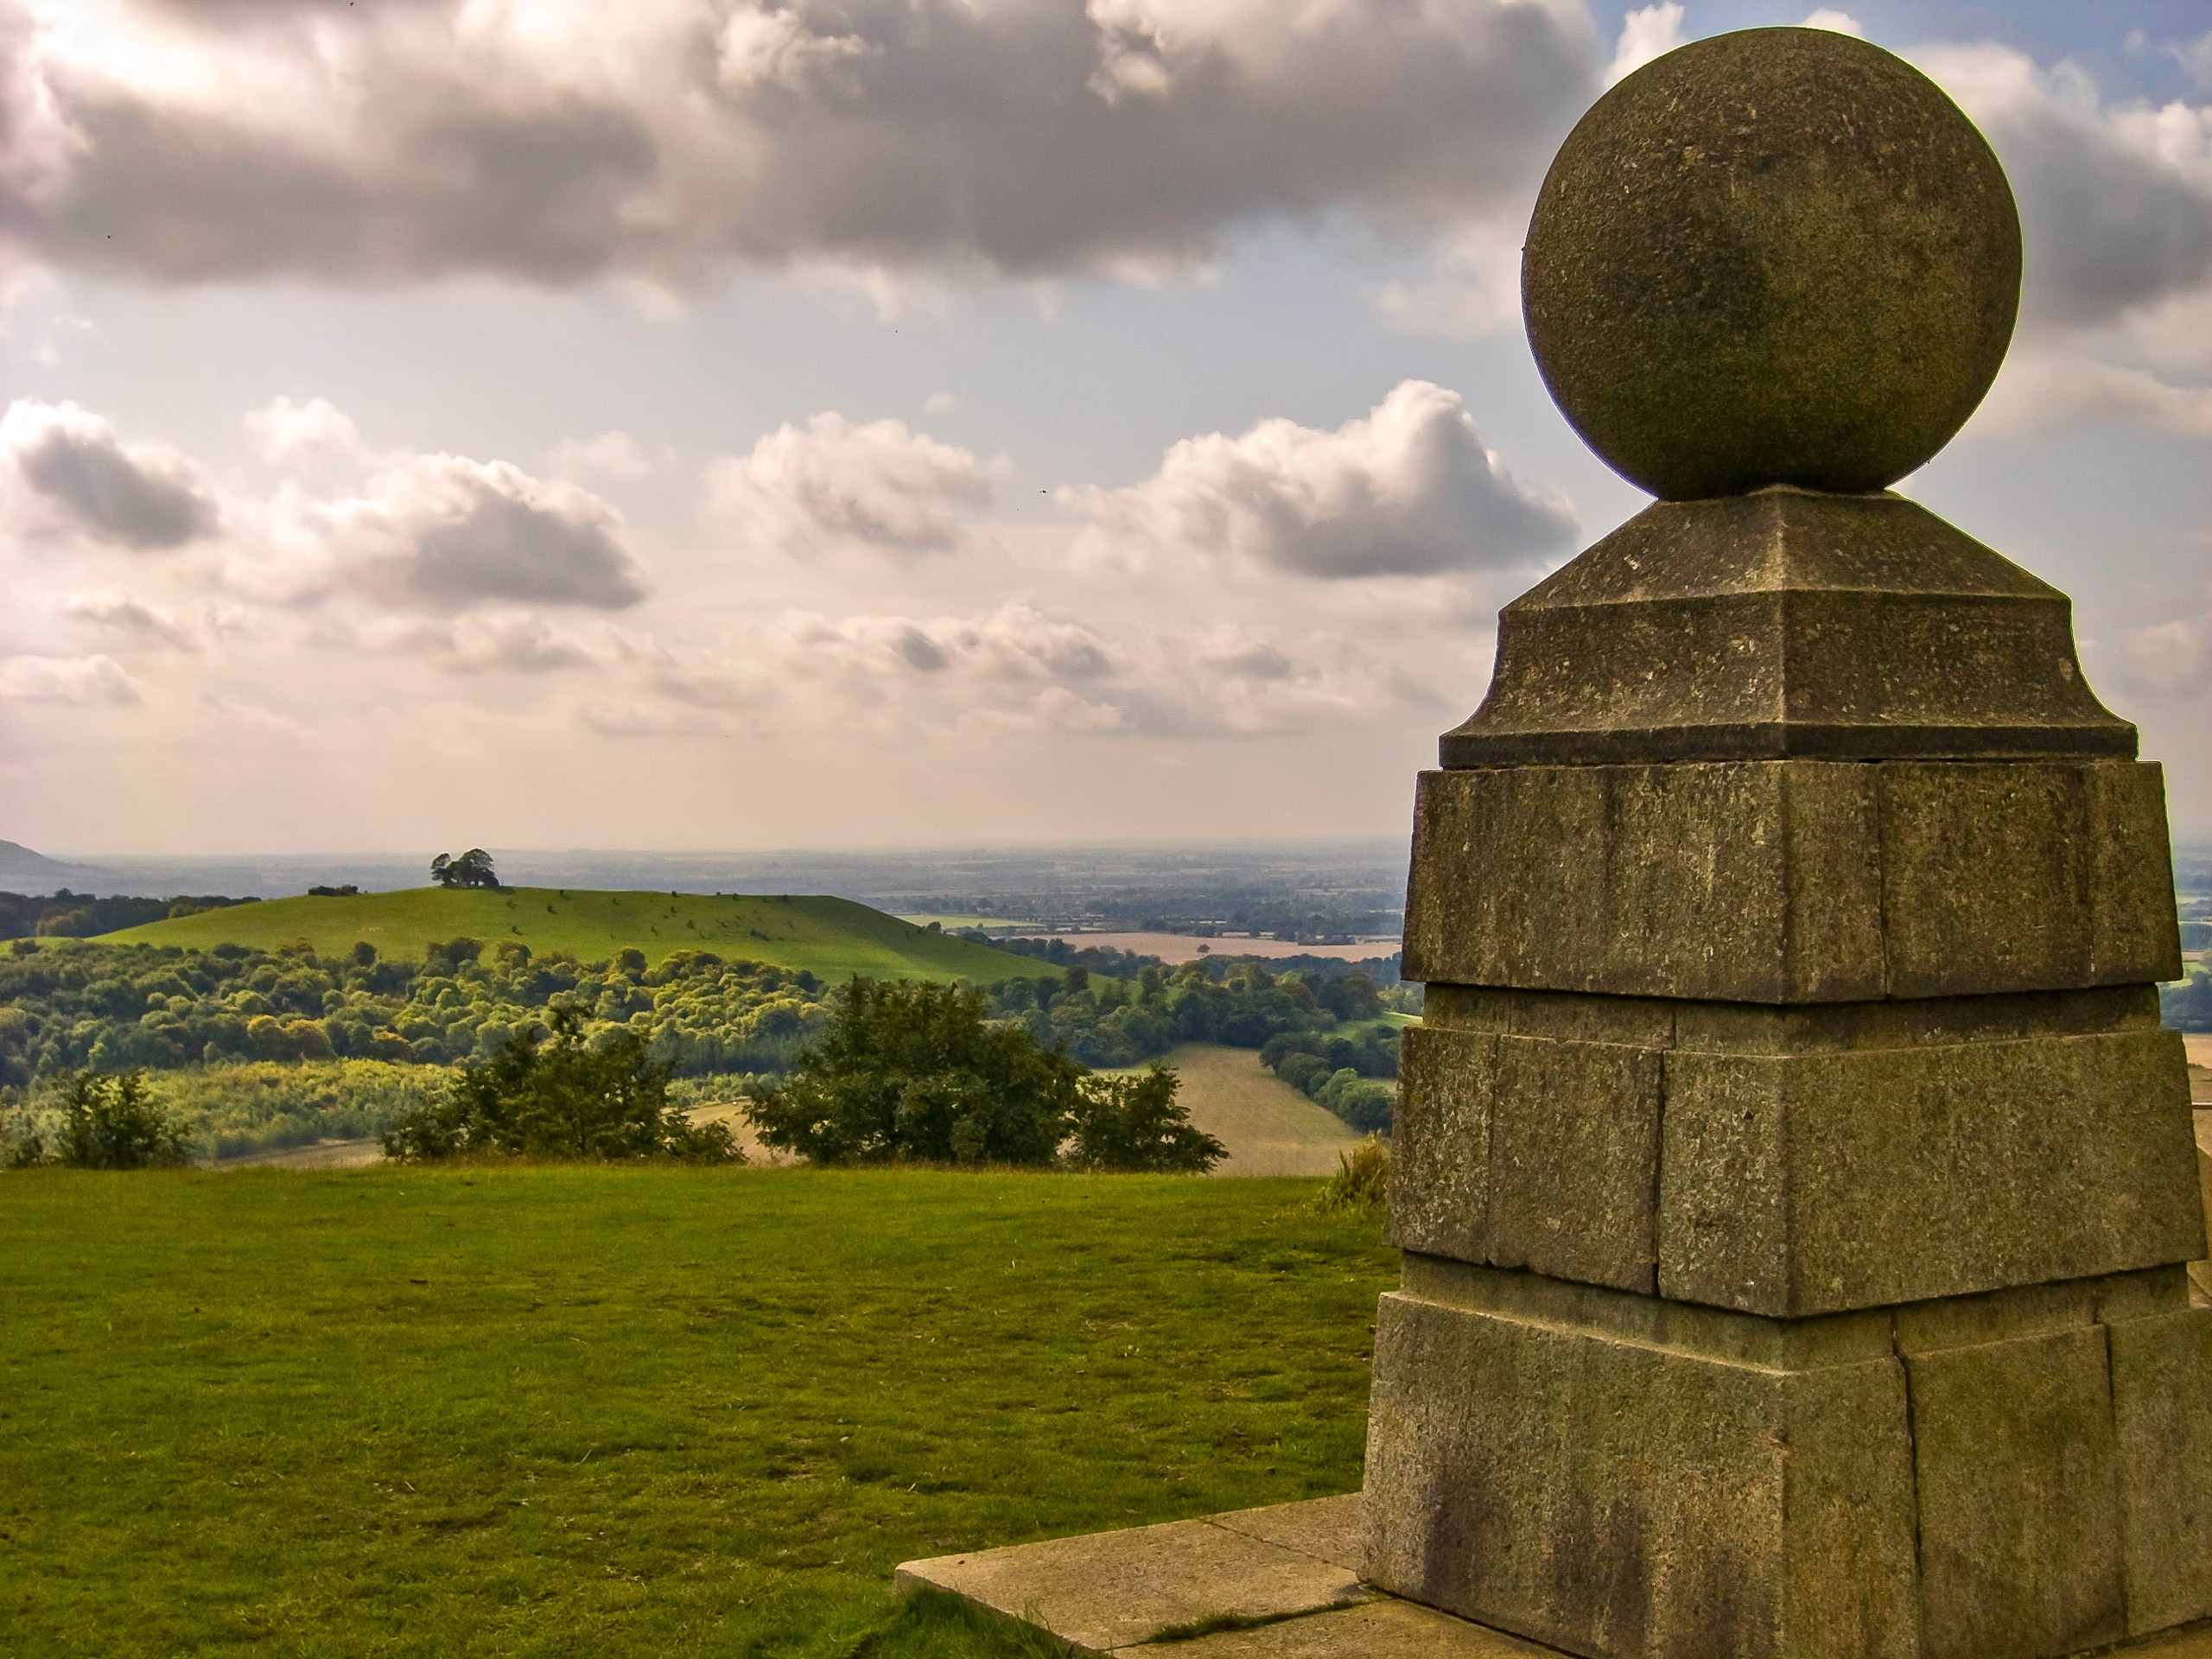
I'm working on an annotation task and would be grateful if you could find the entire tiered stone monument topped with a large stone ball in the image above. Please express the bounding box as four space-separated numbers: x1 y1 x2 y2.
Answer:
1365 29 2212 1659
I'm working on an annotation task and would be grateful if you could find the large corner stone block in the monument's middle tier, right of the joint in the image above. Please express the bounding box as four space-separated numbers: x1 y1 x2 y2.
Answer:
1663 1031 2205 1314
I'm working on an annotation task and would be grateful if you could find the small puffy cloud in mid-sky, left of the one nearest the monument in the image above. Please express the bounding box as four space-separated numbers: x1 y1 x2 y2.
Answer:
706 411 991 553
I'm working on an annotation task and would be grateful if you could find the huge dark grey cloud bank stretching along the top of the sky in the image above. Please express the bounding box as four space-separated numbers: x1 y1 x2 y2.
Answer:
0 0 1592 288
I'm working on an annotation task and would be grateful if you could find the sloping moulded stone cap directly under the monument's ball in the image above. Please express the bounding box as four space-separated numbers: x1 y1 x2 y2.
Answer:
1440 489 2134 769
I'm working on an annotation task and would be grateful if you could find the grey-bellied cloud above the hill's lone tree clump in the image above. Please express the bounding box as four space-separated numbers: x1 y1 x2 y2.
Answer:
404 480 644 611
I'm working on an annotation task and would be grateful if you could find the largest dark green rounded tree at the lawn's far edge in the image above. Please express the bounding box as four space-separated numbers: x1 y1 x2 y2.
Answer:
746 978 1084 1164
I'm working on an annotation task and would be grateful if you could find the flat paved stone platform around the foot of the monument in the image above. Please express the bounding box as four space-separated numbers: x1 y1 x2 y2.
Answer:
898 1493 2212 1659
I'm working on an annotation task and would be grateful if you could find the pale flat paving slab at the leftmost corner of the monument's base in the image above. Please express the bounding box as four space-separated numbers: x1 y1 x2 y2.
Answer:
898 1500 1367 1652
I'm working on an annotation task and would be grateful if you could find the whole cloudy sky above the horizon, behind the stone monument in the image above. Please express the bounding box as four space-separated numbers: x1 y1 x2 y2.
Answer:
0 0 2212 856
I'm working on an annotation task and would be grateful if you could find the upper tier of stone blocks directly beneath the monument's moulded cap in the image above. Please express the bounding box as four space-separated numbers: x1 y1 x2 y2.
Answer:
1405 761 2179 1004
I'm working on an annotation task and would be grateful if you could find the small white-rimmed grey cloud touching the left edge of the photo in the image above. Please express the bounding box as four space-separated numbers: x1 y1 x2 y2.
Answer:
0 398 217 553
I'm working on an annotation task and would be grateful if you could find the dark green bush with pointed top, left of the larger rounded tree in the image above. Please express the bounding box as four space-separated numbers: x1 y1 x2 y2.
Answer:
383 1008 741 1161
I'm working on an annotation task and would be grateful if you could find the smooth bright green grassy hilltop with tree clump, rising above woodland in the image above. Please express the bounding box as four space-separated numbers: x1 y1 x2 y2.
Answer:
102 887 1042 984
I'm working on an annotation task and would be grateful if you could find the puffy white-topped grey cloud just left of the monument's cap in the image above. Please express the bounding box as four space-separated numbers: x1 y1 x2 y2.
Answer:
1062 380 1575 577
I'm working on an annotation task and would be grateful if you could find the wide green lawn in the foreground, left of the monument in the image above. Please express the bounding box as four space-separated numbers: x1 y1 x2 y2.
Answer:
0 1168 1394 1659
